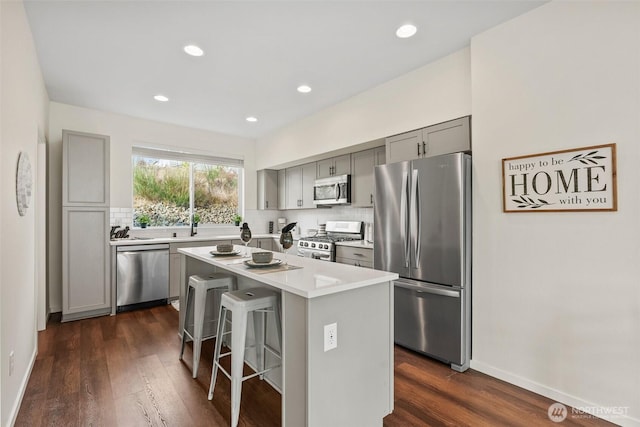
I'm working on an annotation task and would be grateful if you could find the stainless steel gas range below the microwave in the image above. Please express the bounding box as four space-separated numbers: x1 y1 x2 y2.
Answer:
298 221 363 261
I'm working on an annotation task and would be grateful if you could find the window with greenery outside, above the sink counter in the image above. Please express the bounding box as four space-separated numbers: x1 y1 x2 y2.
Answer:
132 147 243 227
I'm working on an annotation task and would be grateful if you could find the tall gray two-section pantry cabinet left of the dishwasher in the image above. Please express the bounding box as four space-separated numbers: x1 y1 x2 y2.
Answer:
62 130 111 322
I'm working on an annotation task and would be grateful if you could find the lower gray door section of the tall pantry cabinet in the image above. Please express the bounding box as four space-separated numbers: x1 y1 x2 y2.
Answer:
62 206 111 322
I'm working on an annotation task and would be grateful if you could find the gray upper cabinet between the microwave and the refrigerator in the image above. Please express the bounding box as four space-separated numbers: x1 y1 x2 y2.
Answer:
351 146 385 207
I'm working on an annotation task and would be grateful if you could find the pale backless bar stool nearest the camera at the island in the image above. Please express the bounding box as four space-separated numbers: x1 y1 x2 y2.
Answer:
209 288 282 427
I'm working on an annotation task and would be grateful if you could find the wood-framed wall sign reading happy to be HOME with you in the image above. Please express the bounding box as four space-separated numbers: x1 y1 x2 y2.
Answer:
502 144 618 212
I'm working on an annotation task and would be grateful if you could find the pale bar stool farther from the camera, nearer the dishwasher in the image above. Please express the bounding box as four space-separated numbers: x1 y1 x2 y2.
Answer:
180 273 235 378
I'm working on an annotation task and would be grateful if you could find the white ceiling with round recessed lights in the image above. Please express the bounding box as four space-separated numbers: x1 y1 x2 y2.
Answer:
25 0 544 138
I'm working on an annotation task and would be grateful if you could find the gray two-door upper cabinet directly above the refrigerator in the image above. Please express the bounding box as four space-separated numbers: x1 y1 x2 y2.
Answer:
386 116 471 163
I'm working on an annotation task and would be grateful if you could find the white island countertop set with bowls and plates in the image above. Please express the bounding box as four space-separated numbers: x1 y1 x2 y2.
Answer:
178 245 398 298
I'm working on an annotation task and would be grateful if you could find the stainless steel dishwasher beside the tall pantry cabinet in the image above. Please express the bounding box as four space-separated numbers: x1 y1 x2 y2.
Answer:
116 244 169 312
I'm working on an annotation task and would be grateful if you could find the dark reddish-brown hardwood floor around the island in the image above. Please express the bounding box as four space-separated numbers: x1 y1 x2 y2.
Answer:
16 305 612 427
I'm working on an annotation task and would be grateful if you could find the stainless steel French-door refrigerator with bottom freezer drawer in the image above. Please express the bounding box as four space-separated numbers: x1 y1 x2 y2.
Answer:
374 153 471 372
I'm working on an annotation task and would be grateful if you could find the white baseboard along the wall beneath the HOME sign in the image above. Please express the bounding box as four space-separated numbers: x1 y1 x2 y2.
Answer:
471 360 640 427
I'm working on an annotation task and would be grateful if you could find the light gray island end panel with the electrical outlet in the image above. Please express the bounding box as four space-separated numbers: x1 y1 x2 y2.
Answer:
306 282 393 427
